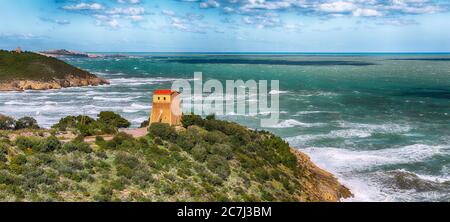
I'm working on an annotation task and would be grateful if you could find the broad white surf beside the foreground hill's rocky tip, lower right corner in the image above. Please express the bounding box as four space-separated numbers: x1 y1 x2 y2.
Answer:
294 144 450 201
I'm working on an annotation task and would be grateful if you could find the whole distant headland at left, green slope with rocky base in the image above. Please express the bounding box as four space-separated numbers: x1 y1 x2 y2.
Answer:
0 50 108 91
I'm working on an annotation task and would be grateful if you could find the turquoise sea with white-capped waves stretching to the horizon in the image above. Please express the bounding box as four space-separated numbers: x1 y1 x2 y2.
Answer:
0 53 450 201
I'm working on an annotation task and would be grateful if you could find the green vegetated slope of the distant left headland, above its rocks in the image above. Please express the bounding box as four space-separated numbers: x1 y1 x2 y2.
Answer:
0 50 93 82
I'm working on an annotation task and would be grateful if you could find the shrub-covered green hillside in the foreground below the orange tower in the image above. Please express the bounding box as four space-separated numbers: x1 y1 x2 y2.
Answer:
0 114 349 201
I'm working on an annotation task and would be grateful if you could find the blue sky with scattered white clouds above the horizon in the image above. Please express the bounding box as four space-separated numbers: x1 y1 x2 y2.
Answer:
0 0 450 52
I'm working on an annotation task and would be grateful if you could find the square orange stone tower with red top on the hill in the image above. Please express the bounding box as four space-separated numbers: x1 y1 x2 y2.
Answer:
150 89 182 126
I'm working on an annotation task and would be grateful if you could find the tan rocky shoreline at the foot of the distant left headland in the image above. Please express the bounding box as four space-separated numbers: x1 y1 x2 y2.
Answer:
0 75 109 91
